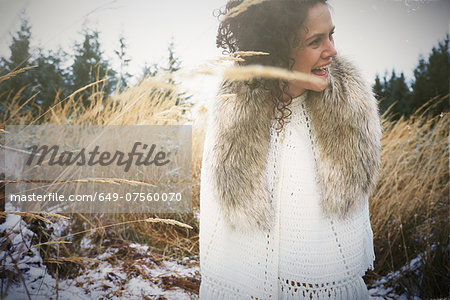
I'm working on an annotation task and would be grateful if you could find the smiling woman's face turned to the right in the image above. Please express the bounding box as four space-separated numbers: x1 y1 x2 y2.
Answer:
289 3 337 97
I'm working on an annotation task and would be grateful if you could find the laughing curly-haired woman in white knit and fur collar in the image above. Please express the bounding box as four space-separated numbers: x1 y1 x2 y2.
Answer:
200 0 381 299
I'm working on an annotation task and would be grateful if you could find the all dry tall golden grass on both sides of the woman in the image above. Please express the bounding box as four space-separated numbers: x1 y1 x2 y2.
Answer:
1 65 449 297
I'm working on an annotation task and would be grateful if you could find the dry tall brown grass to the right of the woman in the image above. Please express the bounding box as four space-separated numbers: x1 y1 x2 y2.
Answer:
371 95 450 298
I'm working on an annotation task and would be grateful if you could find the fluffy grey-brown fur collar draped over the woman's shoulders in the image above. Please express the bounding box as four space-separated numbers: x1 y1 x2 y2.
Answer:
210 57 381 231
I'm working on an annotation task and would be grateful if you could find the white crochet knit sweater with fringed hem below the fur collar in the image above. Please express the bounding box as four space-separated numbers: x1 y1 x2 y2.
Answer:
200 93 375 300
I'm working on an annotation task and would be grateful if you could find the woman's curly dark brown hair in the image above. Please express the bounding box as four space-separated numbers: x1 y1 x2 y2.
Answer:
216 0 327 130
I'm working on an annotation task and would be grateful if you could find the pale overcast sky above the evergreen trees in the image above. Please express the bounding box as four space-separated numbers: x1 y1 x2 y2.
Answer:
0 0 450 99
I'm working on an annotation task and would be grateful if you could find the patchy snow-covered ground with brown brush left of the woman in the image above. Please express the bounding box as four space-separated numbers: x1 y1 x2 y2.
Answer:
0 214 200 300
